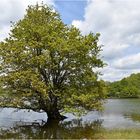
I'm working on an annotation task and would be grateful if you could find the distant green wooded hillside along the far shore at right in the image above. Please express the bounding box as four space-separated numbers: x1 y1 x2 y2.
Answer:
107 73 140 98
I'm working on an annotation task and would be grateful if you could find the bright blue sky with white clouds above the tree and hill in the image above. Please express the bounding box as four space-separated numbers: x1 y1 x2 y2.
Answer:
0 0 140 81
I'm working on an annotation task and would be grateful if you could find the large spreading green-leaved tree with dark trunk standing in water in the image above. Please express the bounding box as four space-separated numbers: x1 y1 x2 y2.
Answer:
0 4 105 119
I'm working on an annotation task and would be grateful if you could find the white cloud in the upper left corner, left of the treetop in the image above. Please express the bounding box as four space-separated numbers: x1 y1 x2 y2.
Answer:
0 0 54 40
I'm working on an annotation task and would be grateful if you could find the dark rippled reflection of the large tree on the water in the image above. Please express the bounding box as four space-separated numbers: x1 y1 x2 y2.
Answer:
0 119 102 139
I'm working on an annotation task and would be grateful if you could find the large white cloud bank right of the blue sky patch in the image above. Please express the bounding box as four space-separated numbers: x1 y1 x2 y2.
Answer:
72 0 140 80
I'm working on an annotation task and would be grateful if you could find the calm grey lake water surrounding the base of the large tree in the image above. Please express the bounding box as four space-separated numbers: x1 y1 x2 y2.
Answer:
0 99 140 138
